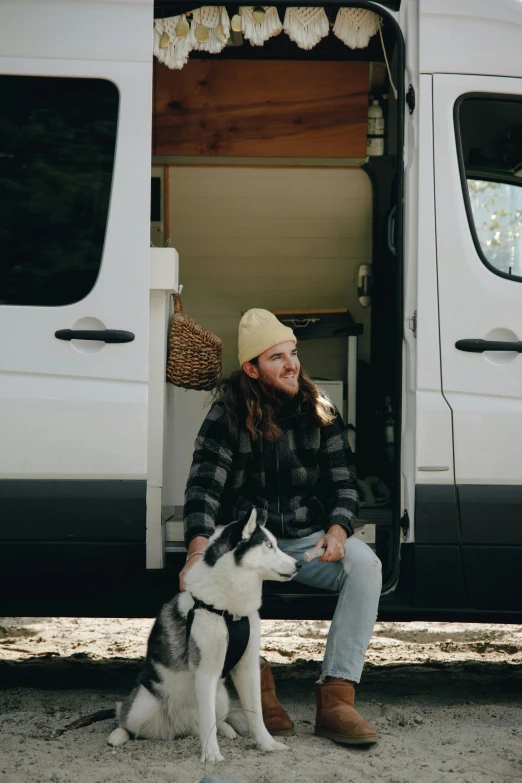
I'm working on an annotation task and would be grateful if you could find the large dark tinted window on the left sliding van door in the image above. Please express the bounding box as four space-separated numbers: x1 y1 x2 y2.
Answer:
0 76 119 306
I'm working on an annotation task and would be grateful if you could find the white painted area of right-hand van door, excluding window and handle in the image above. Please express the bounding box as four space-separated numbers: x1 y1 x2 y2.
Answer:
434 74 522 485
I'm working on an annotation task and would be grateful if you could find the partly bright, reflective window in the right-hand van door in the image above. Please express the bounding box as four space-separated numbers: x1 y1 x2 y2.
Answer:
458 96 522 280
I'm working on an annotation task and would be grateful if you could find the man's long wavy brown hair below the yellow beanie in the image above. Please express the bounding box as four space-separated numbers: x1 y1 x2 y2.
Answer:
214 362 335 441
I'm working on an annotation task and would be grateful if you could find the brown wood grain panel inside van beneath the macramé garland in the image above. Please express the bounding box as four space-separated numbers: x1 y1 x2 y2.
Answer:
154 60 368 158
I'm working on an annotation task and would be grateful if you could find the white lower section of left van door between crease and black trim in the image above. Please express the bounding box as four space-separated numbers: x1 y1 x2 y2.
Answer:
0 374 147 479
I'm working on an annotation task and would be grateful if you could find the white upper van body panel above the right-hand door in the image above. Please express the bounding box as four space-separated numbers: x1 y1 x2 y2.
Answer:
419 0 522 76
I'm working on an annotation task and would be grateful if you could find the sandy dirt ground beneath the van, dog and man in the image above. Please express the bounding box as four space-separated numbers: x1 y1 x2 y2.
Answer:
0 617 522 783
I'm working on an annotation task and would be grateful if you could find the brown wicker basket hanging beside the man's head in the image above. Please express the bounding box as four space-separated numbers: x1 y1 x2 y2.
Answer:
167 294 223 390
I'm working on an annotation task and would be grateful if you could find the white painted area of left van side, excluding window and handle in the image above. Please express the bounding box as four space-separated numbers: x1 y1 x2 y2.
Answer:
0 2 152 479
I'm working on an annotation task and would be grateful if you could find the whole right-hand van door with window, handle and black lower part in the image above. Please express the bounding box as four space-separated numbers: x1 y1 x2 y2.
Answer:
433 74 522 610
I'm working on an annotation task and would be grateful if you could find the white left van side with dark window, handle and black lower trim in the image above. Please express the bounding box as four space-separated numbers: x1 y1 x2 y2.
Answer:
0 0 153 562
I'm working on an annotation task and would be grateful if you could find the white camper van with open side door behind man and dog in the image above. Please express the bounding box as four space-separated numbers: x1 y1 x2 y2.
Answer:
0 0 522 622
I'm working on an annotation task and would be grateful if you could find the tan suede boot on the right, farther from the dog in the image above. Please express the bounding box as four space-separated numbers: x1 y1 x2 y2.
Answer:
315 677 377 745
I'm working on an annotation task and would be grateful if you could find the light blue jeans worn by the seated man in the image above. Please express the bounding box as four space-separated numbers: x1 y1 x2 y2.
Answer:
277 531 382 682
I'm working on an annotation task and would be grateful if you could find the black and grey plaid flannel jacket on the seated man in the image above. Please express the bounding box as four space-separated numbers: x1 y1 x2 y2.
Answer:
183 400 359 546
